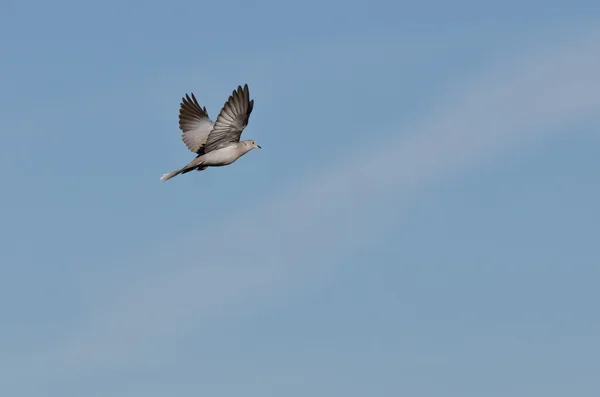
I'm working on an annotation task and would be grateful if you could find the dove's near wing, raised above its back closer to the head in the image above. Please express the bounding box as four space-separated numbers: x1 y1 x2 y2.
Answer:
204 84 254 153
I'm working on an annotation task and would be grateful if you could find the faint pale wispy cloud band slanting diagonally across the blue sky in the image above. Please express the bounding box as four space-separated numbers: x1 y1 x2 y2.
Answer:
24 26 600 378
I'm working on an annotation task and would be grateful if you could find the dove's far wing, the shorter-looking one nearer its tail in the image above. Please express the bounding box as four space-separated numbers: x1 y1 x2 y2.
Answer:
179 93 214 155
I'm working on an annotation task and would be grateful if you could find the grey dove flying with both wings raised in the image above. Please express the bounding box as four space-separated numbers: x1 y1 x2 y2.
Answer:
160 84 261 181
